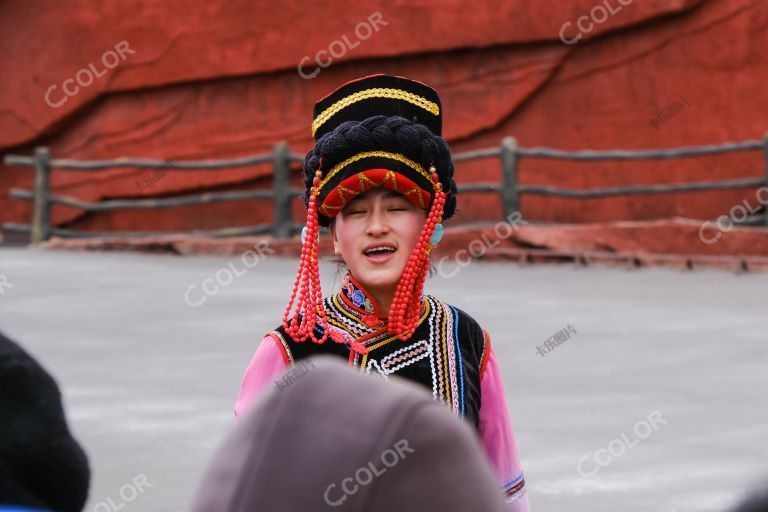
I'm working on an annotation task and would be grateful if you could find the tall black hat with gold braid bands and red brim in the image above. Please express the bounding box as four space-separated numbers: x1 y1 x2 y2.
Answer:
304 74 456 226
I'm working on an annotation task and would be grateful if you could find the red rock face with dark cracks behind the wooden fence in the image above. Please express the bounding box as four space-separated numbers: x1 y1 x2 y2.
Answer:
0 0 768 251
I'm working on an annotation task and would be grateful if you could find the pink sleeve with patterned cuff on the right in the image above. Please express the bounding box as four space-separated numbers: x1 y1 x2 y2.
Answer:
479 348 530 512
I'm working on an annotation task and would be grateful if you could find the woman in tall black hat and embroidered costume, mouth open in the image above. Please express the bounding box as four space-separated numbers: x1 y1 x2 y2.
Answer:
235 75 528 511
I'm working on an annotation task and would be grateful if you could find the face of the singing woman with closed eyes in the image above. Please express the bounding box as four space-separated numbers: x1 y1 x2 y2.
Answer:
330 187 427 300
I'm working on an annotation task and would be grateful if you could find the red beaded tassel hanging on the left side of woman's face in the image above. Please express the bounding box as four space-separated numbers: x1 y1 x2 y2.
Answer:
283 164 329 343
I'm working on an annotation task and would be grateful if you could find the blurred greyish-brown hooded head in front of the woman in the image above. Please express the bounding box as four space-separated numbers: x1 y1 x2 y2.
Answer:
193 356 505 512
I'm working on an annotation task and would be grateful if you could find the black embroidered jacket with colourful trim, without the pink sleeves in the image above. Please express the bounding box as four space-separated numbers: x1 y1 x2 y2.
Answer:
270 275 489 427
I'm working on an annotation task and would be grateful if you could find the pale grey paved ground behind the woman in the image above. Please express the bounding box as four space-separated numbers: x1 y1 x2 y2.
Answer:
0 249 768 512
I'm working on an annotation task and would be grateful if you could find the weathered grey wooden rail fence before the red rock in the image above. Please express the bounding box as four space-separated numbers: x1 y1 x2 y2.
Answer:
3 134 768 244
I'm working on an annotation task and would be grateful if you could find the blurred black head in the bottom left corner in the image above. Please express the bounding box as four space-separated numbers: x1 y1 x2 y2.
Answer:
0 333 90 512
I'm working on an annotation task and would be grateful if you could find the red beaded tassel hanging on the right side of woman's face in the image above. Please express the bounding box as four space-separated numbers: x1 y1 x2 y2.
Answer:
387 166 445 341
